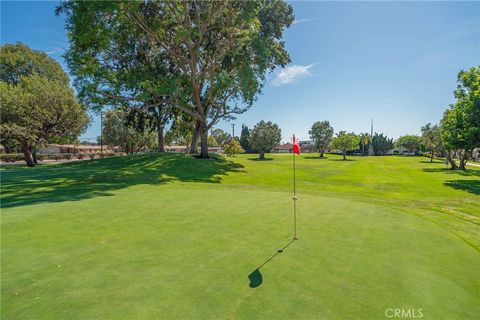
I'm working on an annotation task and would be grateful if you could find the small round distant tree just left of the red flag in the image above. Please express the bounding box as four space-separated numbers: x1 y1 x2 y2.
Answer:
250 120 282 159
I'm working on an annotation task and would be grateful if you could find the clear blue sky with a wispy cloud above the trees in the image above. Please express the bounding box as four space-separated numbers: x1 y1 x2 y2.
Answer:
1 1 480 141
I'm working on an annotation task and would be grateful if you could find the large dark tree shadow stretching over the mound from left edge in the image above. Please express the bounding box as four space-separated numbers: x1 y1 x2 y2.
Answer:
0 153 243 208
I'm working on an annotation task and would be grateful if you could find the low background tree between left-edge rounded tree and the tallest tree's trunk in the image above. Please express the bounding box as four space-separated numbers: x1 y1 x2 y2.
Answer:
103 109 156 154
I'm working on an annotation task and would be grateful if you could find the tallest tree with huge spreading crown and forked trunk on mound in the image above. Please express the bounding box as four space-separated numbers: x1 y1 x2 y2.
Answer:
57 0 293 157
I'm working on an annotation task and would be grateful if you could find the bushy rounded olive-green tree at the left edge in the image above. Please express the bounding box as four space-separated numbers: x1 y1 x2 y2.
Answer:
0 44 89 166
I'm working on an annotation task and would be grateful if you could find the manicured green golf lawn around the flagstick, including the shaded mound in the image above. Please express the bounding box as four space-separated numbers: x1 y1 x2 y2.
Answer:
1 154 480 319
